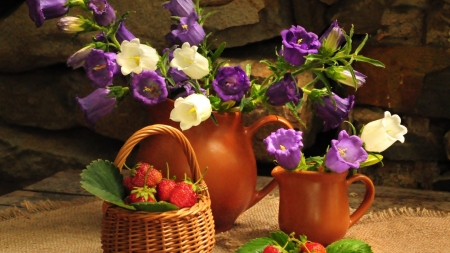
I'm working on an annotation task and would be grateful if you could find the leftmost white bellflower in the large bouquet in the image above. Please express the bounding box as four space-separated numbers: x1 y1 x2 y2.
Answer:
116 38 159 75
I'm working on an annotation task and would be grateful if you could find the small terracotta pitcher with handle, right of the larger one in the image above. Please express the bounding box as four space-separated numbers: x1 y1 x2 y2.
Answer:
272 166 375 245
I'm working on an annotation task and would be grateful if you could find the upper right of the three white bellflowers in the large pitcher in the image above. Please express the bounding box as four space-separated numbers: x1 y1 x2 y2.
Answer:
170 42 209 79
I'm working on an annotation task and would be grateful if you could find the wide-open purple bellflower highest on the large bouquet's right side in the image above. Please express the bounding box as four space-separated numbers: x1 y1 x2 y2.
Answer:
280 26 321 66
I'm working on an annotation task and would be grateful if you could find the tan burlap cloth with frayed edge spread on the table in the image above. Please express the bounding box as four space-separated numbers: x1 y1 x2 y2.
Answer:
0 195 450 253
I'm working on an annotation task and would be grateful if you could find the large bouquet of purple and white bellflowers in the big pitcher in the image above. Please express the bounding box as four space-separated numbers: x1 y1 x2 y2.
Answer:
26 0 384 130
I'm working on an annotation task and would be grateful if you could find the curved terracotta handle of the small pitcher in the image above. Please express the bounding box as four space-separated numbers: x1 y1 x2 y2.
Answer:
347 174 375 228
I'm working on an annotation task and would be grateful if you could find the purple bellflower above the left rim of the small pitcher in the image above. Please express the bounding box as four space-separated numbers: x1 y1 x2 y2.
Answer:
263 128 303 170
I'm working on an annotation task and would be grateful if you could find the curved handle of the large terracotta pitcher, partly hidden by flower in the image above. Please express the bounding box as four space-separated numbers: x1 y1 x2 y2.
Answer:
245 115 294 209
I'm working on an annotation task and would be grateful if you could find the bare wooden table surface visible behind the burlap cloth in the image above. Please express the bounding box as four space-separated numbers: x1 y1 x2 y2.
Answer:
0 170 450 212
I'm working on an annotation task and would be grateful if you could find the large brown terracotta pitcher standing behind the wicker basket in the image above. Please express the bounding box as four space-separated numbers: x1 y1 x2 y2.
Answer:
137 100 292 232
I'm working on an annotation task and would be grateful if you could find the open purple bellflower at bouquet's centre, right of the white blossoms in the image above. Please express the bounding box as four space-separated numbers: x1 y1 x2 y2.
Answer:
212 66 250 102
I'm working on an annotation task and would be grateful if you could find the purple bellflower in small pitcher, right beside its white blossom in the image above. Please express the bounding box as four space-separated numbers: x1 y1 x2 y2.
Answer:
325 130 368 173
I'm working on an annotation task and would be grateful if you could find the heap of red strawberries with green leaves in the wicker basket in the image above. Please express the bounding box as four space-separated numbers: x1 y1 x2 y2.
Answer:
81 160 204 212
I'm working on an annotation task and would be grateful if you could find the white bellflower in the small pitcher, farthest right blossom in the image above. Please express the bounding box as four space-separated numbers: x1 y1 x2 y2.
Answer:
361 111 408 152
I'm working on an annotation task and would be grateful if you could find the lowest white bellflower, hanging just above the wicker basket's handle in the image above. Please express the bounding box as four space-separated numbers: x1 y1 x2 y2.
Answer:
170 94 212 131
